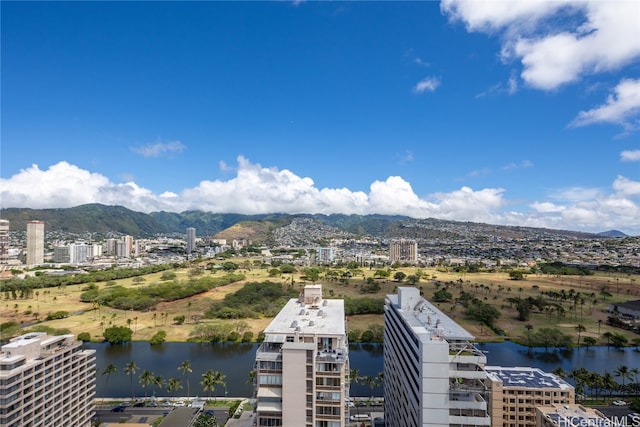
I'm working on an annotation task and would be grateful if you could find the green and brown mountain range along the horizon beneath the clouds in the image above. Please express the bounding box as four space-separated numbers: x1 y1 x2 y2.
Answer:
0 203 626 243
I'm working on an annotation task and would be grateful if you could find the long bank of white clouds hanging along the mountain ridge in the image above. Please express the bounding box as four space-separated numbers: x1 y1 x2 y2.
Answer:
0 160 640 234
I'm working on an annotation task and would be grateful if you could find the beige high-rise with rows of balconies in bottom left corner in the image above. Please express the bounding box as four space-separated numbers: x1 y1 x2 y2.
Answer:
0 332 96 427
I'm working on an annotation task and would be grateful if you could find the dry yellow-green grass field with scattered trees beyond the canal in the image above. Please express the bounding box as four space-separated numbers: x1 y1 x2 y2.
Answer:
0 261 640 344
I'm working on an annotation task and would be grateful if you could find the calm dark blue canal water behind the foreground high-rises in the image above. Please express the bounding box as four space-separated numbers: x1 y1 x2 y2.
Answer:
85 342 640 397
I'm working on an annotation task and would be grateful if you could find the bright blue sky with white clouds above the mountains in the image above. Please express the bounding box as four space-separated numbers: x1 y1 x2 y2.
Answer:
0 0 640 235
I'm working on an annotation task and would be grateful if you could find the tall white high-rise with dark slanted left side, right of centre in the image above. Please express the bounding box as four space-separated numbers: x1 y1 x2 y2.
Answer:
383 287 491 427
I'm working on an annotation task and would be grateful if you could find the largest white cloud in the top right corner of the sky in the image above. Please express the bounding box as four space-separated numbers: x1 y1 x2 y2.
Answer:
441 0 640 90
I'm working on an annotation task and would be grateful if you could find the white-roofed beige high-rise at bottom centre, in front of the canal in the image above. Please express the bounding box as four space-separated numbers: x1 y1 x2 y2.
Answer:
255 285 350 427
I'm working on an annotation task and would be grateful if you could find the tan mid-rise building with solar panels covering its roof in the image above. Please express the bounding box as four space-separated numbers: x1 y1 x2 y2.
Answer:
485 366 575 427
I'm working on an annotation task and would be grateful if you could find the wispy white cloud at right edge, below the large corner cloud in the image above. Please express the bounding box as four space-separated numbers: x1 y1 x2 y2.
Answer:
571 79 640 127
